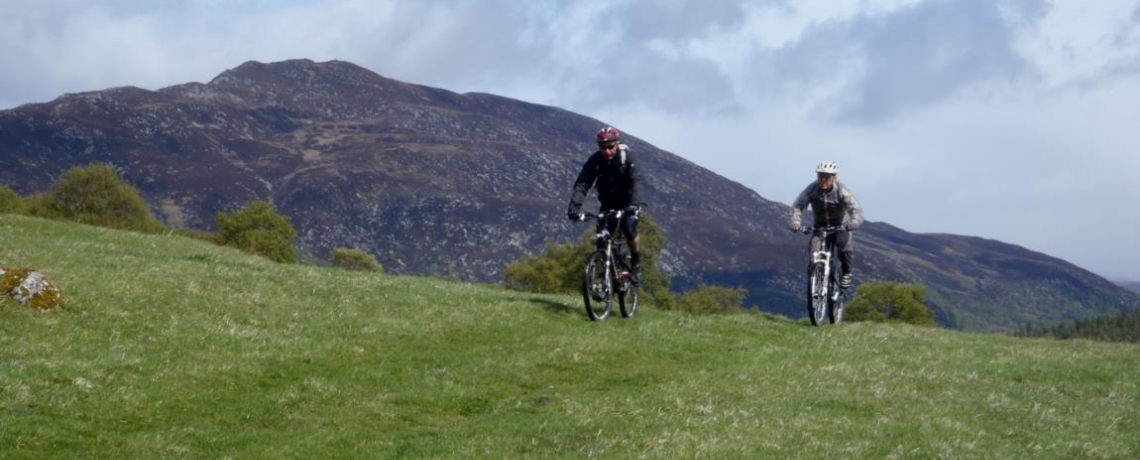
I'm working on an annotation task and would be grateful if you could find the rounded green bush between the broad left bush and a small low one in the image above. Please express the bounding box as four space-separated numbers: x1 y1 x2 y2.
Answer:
218 200 298 263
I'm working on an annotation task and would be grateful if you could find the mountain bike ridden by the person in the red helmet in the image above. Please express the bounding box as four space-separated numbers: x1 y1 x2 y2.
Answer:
581 210 638 321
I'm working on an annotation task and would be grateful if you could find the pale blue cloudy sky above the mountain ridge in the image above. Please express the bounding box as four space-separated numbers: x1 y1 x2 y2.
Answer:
0 0 1140 280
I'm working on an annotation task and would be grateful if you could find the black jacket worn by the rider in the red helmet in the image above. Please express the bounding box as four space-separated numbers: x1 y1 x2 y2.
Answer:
568 143 642 213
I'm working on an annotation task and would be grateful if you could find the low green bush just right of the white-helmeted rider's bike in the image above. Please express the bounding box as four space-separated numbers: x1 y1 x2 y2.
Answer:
845 282 938 327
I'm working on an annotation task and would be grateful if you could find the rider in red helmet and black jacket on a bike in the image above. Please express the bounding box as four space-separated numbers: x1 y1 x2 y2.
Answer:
567 126 642 284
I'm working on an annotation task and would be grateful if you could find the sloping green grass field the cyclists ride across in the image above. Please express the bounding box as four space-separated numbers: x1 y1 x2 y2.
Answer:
0 215 1140 460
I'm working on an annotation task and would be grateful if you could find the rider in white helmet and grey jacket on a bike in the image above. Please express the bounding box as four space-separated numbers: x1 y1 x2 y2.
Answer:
788 162 863 289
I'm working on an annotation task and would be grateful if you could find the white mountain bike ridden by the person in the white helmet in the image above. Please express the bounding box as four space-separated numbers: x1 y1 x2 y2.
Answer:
803 227 847 326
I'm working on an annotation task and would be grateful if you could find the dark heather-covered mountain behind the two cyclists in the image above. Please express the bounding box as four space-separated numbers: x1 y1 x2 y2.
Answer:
0 60 1140 330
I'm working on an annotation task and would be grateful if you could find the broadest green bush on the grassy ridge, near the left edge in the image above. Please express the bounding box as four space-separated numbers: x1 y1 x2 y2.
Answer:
27 163 165 233
